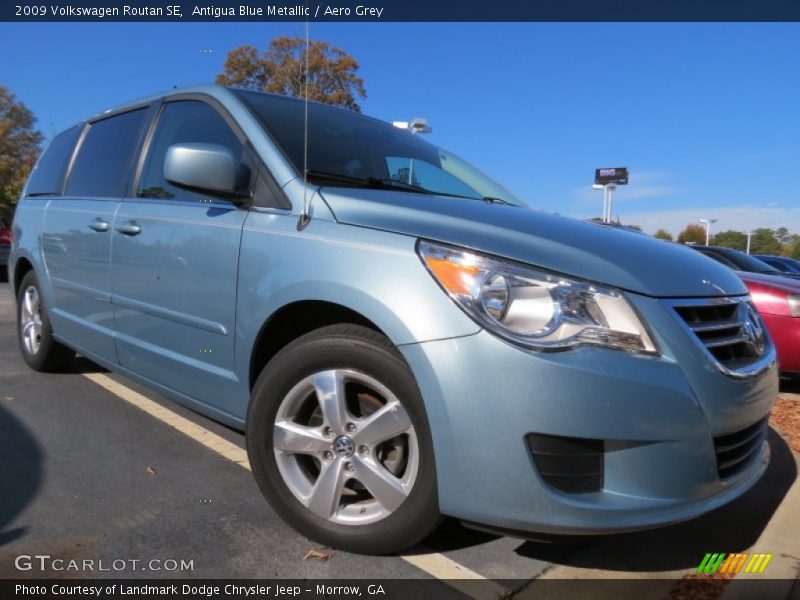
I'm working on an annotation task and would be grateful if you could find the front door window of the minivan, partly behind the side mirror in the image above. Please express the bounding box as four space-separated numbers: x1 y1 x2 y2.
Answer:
137 100 245 201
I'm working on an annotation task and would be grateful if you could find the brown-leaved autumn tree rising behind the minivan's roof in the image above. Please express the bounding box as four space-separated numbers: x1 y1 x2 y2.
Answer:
216 36 367 112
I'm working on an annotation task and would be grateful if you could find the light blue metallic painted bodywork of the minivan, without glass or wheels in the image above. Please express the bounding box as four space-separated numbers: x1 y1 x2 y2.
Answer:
9 86 777 533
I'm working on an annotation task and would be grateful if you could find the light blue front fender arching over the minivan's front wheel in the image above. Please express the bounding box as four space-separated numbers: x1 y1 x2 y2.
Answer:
236 212 480 376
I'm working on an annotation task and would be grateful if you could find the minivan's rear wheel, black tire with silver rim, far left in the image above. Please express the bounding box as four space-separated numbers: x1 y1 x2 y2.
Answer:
17 271 75 371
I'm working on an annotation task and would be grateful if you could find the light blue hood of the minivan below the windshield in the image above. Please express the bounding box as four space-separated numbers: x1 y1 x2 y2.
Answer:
320 187 747 298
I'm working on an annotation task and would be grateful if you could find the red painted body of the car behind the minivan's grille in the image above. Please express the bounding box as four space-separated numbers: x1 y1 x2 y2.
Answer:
736 271 800 374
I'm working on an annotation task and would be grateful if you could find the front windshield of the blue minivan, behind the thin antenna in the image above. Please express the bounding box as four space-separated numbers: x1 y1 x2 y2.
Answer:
233 90 525 206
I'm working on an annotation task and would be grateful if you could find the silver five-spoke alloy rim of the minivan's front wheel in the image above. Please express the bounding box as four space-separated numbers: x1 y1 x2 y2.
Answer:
272 369 419 525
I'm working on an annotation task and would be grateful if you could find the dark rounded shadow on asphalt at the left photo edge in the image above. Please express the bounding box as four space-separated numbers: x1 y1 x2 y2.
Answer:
0 405 43 546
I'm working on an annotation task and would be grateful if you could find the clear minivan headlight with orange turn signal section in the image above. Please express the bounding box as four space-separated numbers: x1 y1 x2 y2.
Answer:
417 241 658 353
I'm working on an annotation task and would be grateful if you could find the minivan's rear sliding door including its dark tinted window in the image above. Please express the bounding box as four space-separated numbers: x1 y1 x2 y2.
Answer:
41 107 147 361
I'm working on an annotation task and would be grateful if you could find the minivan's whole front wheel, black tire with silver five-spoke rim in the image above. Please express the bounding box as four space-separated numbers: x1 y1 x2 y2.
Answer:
246 325 441 554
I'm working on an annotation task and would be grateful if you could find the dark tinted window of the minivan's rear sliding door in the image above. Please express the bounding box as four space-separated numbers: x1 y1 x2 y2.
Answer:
67 108 146 197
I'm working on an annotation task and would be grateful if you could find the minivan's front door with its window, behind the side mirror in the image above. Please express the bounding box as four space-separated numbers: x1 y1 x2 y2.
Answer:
111 99 250 409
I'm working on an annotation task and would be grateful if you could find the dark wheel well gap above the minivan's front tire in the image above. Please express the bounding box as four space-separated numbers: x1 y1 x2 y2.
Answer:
250 300 386 390
